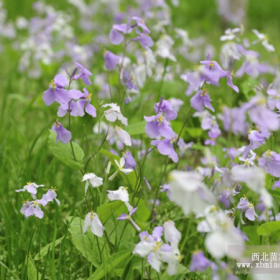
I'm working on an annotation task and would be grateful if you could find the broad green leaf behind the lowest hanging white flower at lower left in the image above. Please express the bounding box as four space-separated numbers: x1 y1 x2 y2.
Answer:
68 217 106 267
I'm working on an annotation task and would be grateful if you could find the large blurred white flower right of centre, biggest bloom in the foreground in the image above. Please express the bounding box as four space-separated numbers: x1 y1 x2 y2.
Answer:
170 171 216 215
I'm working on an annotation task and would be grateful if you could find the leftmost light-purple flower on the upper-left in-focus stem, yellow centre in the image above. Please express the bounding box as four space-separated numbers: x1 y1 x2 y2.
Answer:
43 74 69 106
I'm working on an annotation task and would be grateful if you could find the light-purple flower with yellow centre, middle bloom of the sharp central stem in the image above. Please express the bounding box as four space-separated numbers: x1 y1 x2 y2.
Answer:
144 114 174 138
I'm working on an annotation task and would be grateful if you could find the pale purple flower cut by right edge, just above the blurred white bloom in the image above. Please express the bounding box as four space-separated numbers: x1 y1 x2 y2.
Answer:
259 151 280 177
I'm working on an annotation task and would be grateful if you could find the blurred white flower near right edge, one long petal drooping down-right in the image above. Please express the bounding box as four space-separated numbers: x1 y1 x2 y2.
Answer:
231 165 272 208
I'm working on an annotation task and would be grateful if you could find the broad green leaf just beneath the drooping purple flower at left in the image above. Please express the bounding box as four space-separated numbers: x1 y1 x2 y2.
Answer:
49 130 84 169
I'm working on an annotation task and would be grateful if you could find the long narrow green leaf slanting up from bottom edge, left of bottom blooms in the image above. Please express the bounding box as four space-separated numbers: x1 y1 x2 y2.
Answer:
87 250 131 280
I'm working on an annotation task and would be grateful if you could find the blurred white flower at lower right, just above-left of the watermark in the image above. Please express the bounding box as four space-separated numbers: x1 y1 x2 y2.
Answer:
205 211 244 259
